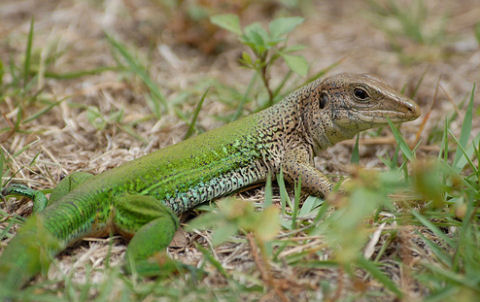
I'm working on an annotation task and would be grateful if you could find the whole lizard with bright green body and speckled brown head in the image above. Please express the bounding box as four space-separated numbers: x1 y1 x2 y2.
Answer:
0 73 420 290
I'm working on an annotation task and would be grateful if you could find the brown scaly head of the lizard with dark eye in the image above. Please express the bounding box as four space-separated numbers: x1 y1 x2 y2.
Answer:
305 73 420 149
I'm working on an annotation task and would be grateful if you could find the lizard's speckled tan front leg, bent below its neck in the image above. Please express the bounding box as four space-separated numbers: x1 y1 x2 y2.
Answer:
281 145 333 197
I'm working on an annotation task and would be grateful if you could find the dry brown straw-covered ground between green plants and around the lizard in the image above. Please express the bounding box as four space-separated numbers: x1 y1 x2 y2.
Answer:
0 0 480 300
